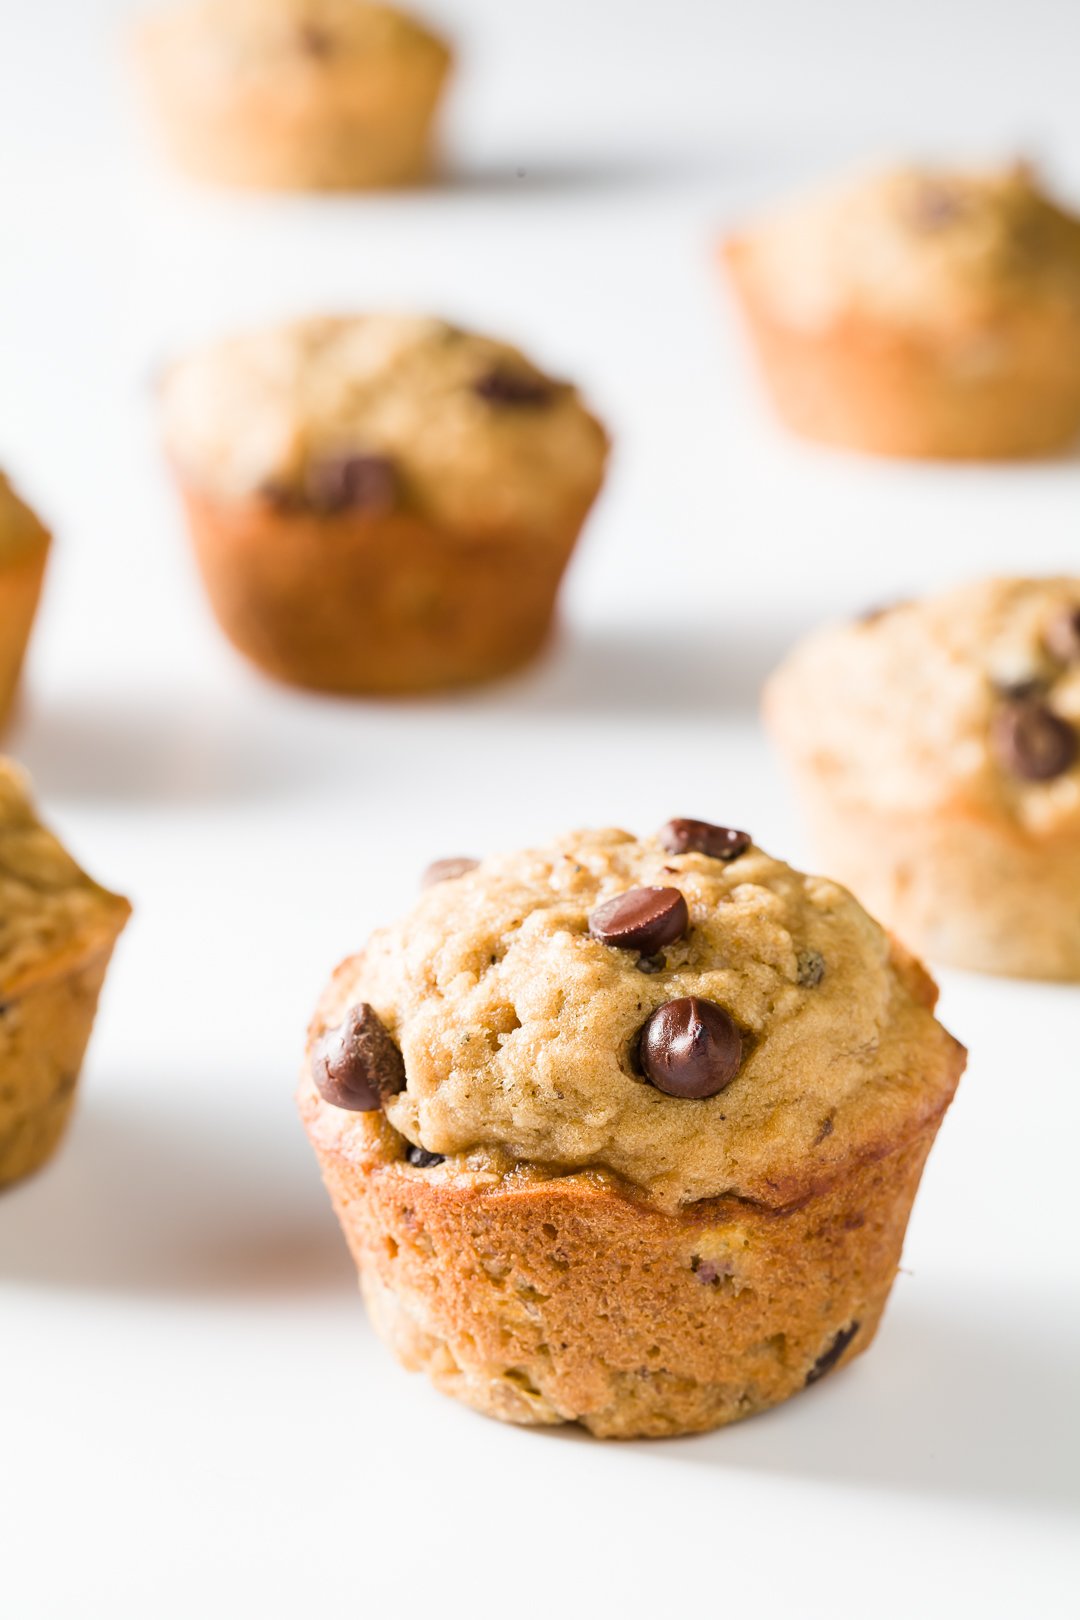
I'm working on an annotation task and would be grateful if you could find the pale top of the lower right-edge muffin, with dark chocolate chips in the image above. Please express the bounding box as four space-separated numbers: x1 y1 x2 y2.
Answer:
766 578 1080 836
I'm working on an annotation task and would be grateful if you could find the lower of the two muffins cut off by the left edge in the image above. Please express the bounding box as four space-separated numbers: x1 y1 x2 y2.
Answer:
0 760 131 1186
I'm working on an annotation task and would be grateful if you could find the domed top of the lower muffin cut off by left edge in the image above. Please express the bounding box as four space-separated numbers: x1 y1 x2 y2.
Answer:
0 758 131 998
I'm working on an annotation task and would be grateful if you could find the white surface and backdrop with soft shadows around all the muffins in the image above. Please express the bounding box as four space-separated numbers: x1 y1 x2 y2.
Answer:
0 0 1080 1620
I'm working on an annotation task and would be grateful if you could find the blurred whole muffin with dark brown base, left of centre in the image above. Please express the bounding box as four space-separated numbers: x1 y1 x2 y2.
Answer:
162 314 607 693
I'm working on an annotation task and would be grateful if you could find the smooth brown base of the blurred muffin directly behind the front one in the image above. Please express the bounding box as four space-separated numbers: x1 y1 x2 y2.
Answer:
181 483 586 695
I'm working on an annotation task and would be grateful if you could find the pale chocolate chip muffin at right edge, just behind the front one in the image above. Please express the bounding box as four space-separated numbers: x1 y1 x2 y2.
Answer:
766 578 1080 980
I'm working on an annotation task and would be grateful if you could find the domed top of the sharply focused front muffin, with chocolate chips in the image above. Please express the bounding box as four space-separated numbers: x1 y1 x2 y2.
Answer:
301 821 963 1209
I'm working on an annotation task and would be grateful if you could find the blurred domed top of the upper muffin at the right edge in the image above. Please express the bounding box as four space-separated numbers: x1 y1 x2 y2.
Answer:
733 164 1080 330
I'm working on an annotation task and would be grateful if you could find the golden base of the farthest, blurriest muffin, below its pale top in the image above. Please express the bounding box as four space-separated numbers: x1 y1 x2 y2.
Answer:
138 36 450 191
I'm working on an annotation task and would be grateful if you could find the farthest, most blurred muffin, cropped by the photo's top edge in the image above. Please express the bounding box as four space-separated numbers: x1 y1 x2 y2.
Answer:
136 0 450 191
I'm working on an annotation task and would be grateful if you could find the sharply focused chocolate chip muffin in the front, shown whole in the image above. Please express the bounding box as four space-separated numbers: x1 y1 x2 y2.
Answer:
300 820 963 1437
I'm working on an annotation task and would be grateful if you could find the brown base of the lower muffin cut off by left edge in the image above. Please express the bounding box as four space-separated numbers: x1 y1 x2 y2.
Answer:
0 939 126 1187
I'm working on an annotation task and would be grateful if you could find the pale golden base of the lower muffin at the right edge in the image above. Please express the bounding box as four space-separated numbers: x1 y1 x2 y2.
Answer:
795 770 1080 982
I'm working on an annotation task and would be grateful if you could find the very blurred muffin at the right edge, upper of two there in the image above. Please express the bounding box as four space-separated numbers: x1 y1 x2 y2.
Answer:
724 165 1080 460
